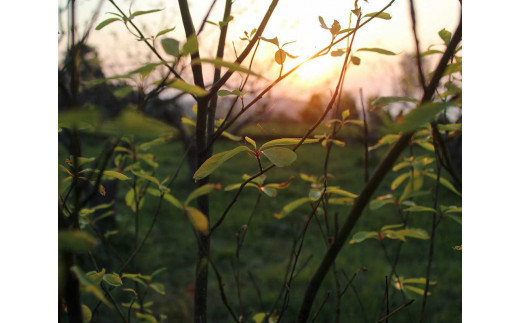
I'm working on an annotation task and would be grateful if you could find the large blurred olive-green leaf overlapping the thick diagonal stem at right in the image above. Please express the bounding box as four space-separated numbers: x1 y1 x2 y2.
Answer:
394 102 456 132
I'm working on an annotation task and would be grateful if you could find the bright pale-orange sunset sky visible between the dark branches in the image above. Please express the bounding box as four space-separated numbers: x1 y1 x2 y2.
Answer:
60 0 460 105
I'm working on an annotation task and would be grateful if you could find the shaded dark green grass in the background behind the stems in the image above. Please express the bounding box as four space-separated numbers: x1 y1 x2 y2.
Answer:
60 135 462 322
